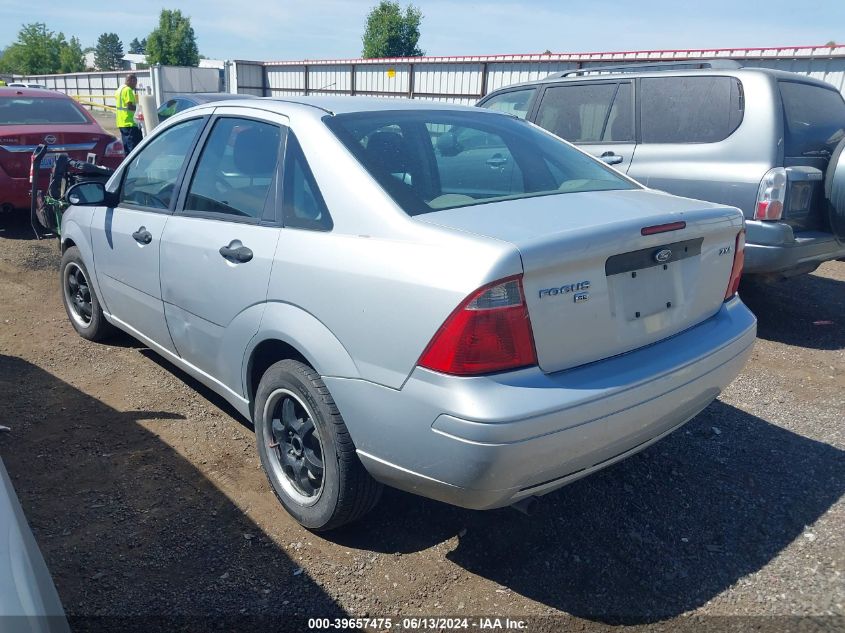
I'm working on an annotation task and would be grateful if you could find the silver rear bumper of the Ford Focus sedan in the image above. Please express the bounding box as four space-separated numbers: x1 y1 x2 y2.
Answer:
325 299 756 509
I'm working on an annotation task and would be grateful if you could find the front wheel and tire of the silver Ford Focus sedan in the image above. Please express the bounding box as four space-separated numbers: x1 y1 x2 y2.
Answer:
59 246 115 341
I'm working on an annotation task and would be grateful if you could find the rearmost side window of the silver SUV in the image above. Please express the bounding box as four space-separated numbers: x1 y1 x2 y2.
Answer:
640 76 743 143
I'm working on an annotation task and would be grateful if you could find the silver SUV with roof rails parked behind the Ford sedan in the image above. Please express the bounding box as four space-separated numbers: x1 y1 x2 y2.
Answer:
478 60 845 278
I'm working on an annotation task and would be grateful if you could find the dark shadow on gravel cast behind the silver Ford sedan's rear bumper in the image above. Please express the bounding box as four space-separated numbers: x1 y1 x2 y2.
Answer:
330 401 845 624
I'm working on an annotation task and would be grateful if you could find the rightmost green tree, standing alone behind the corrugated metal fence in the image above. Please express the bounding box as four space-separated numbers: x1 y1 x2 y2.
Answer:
361 0 425 58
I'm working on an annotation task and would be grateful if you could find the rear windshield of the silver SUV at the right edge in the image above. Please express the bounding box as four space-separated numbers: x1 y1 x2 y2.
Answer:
780 81 845 156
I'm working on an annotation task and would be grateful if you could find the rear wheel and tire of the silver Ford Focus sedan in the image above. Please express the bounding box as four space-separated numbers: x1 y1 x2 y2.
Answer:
253 359 382 532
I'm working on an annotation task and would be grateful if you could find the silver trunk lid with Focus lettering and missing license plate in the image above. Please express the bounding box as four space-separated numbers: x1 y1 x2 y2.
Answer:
417 190 742 372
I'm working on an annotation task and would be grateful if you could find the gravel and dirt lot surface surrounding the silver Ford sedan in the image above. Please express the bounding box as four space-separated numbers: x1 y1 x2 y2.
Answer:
0 216 845 631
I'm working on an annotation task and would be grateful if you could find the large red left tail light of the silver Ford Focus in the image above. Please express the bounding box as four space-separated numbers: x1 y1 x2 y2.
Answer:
419 275 537 376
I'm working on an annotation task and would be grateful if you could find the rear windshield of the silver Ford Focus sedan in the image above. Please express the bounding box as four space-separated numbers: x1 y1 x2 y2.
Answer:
323 110 638 215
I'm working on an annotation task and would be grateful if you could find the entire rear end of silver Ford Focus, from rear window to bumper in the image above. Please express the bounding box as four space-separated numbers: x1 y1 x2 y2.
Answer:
326 112 756 509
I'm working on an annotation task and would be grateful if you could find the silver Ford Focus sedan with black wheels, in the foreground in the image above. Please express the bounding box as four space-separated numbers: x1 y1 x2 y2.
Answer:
61 97 756 529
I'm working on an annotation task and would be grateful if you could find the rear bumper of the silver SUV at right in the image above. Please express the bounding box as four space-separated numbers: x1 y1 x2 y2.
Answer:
744 221 845 277
